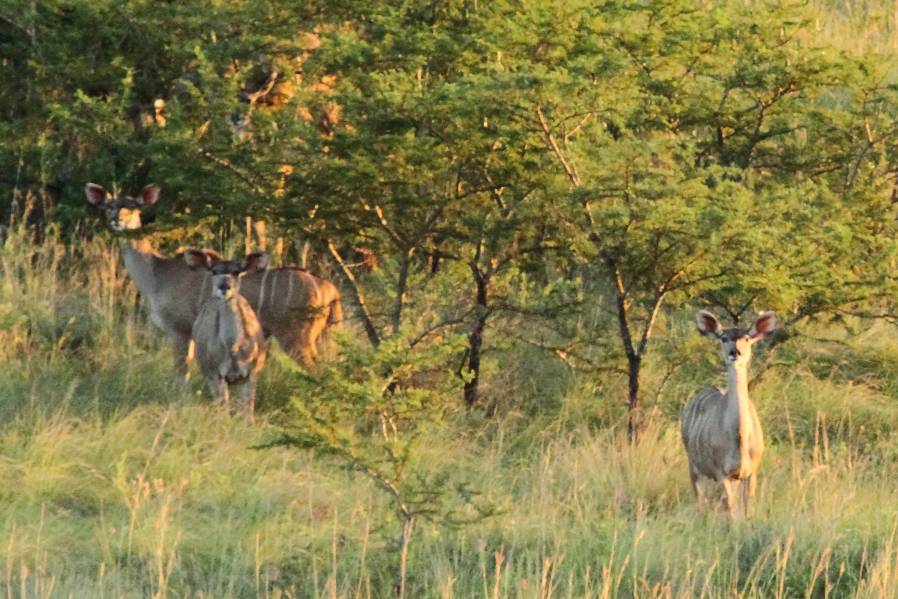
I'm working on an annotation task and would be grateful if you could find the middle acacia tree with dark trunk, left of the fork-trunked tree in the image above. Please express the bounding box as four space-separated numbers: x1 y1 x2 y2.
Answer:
291 2 568 406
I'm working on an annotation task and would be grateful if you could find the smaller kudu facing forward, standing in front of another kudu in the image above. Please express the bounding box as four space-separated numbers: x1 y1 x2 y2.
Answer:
184 249 268 418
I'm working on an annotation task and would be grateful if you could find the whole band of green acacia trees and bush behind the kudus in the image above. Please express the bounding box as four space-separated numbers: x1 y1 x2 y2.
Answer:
0 0 898 434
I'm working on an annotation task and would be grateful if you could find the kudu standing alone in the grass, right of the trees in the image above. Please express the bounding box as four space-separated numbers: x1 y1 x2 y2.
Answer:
680 310 777 515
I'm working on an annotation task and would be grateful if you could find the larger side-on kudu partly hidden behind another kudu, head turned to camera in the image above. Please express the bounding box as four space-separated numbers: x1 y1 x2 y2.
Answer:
84 183 343 379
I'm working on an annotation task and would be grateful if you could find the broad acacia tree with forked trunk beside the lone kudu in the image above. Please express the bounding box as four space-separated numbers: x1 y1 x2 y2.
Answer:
476 1 894 440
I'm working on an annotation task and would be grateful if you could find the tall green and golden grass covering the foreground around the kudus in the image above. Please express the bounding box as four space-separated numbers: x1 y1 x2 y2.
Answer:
0 218 898 597
